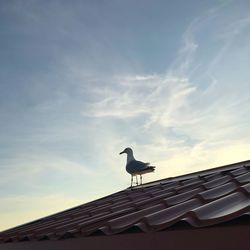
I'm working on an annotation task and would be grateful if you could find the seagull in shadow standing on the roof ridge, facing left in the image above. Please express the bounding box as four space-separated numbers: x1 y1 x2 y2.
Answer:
120 148 155 187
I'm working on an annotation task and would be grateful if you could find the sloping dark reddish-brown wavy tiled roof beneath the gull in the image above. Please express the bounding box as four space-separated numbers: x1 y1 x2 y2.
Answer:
0 161 250 243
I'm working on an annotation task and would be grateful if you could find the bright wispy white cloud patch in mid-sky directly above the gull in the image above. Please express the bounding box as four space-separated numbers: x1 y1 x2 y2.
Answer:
83 74 195 128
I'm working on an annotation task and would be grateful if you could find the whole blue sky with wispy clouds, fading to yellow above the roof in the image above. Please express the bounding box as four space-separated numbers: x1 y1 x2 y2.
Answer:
0 0 250 230
